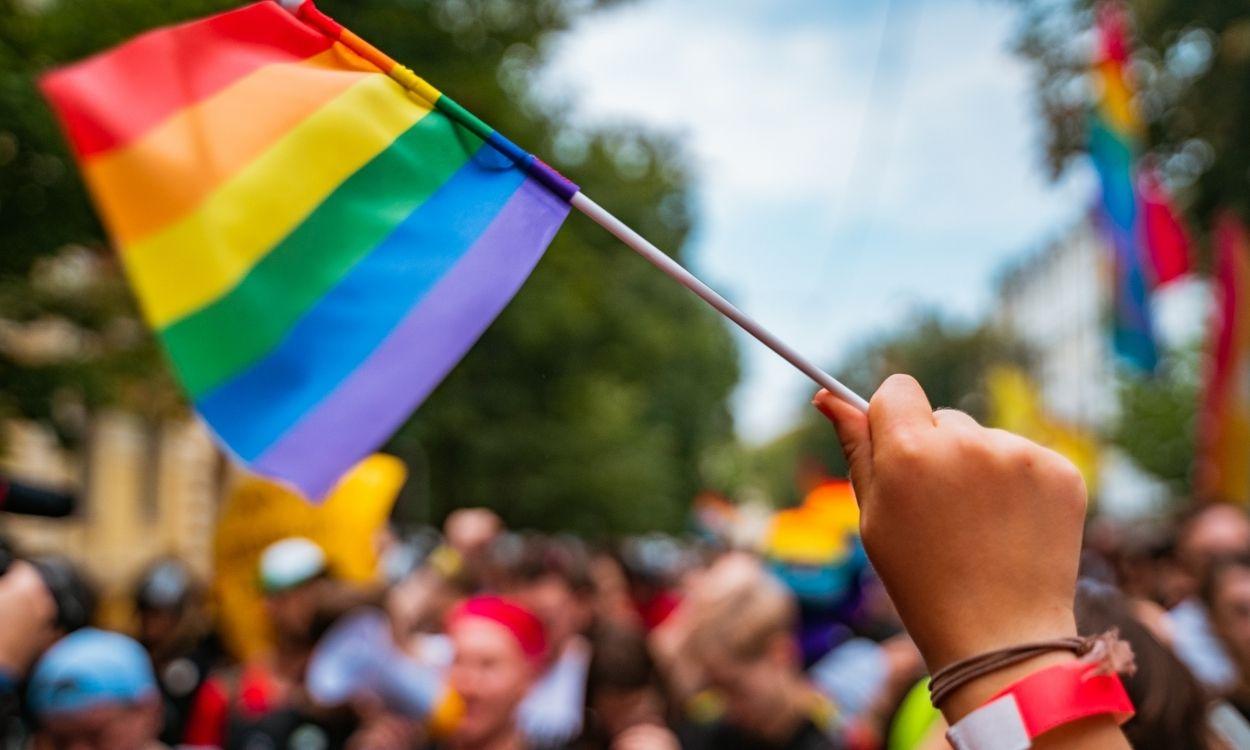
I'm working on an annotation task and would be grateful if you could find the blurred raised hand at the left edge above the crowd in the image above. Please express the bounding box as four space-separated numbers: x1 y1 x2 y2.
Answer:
0 560 58 678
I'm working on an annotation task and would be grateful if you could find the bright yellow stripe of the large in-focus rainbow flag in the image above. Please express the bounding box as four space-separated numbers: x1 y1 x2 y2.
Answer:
121 75 430 328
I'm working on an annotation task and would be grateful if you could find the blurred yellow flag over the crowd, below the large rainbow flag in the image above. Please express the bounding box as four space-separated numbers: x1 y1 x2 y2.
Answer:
213 454 408 659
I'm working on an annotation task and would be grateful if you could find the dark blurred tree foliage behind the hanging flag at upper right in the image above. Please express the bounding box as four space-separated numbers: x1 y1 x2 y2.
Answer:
1014 0 1250 237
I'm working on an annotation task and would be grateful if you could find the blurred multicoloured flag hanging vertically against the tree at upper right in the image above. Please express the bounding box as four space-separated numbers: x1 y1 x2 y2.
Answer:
1089 3 1189 371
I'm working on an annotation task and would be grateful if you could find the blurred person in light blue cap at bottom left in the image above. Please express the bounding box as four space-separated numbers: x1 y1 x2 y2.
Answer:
26 628 164 750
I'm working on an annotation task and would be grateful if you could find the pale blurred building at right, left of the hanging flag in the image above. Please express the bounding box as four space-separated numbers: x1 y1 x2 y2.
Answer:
994 220 1194 516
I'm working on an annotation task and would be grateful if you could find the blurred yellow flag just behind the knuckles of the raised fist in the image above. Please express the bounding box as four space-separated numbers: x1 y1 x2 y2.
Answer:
986 365 1099 496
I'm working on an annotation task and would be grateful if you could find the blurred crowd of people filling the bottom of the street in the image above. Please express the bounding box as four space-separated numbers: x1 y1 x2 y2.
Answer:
0 492 1250 750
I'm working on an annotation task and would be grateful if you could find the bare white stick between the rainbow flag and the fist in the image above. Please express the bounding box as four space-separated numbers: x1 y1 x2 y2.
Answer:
569 193 868 413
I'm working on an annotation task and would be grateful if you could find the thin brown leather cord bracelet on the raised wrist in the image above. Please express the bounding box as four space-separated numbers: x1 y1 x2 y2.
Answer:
929 629 1134 708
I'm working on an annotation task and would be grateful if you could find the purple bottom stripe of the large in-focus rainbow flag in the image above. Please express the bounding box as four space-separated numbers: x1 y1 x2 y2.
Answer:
254 179 569 499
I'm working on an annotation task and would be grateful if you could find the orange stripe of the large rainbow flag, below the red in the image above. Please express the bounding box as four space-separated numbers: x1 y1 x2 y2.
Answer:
83 46 376 246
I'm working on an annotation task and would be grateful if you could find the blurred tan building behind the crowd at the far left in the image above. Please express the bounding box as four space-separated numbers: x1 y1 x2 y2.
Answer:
0 411 229 624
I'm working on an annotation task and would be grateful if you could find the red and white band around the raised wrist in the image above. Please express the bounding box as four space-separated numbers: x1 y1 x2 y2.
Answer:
946 660 1134 750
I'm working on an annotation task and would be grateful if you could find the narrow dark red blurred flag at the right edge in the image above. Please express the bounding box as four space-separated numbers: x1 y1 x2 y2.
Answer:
1195 214 1250 503
